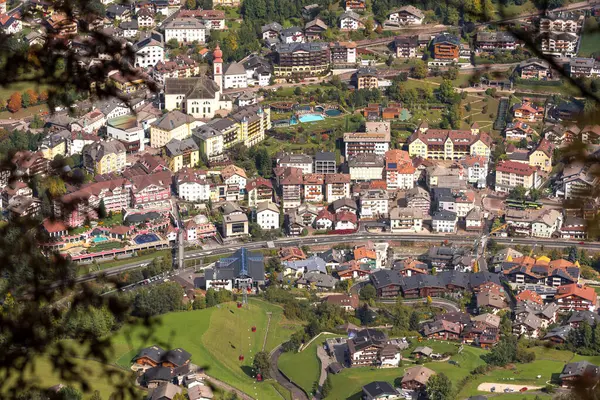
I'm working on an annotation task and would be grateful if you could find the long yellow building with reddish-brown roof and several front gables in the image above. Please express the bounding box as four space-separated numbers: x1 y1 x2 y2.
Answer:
408 123 492 160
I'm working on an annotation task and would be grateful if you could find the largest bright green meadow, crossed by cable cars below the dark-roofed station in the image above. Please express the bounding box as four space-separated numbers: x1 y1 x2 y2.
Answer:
113 300 298 399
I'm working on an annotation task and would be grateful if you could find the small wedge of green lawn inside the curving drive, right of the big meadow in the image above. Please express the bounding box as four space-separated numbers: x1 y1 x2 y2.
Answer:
278 335 340 393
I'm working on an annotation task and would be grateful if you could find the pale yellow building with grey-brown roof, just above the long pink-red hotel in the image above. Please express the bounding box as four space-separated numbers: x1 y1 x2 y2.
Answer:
82 140 127 174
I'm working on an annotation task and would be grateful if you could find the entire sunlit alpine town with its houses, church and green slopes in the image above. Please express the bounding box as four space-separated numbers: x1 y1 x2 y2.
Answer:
0 0 600 400
